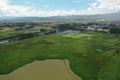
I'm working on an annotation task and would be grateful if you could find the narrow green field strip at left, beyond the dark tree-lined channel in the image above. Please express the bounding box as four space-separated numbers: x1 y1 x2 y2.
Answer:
0 26 52 39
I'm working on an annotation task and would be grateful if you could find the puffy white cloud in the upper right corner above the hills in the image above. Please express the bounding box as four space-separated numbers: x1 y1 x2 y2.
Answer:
88 0 120 14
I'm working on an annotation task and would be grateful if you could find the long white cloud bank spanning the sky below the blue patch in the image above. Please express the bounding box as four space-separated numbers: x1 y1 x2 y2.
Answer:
0 0 120 16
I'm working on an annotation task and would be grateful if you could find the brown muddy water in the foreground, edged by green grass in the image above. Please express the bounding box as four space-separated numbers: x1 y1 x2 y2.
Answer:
0 60 82 80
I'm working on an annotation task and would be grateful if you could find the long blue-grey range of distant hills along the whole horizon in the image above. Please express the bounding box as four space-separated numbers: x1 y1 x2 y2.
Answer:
0 12 120 21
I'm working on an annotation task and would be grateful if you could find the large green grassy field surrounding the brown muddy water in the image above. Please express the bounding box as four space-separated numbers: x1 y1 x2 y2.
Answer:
0 33 120 80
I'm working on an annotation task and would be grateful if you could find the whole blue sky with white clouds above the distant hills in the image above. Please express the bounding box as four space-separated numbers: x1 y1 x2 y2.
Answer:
0 0 120 17
